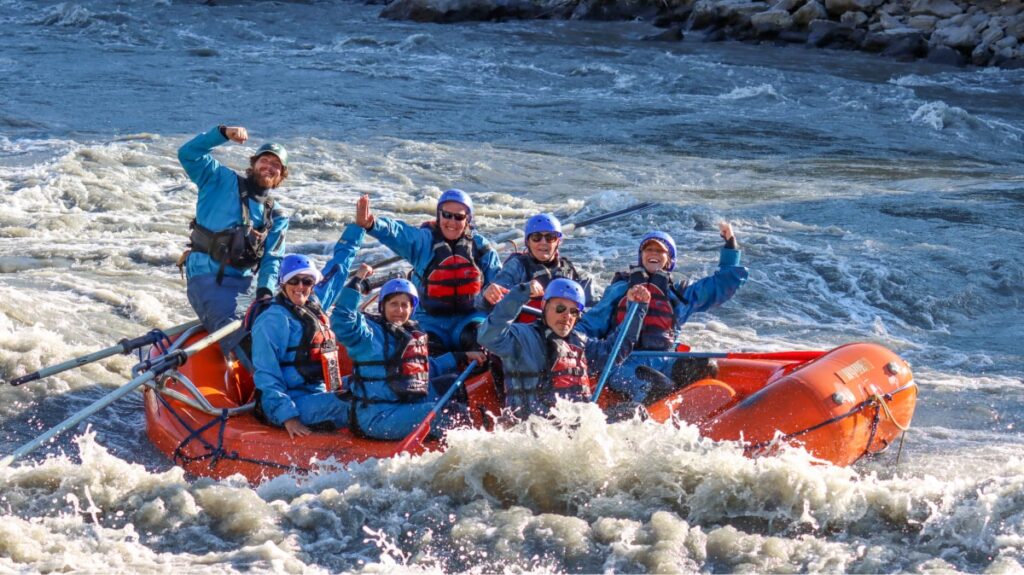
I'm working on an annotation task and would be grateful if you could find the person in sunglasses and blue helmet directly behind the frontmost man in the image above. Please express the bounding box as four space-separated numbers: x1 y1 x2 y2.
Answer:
476 214 595 323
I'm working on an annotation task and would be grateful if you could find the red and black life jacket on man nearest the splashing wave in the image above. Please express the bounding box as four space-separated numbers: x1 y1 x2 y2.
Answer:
505 319 590 408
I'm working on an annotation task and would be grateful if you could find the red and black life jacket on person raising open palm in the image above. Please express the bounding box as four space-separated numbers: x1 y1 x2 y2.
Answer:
420 222 490 315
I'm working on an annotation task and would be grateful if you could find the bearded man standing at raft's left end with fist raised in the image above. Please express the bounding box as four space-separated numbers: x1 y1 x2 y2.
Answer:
178 126 288 366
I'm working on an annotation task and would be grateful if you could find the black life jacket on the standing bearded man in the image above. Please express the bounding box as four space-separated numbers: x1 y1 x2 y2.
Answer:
188 174 275 284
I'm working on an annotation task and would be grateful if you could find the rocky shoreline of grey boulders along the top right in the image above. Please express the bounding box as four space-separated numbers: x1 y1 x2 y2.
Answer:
370 0 1024 69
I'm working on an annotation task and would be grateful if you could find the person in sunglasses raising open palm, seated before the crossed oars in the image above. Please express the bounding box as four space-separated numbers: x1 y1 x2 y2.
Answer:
355 189 502 355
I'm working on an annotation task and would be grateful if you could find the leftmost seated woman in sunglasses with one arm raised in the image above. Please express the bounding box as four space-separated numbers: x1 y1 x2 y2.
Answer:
246 224 366 437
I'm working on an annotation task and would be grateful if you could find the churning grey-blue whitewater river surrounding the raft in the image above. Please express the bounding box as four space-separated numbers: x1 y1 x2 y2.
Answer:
0 0 1024 573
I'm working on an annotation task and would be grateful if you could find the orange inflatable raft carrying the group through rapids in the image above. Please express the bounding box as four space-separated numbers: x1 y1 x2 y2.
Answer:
144 330 918 484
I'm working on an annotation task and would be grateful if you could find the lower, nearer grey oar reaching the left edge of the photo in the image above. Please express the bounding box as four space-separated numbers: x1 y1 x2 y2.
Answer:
0 319 242 469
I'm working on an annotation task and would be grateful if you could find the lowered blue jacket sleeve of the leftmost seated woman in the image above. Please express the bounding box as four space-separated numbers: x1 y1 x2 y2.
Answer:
252 310 299 424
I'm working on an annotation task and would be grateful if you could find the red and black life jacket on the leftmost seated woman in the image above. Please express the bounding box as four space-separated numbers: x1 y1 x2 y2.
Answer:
260 294 346 393
